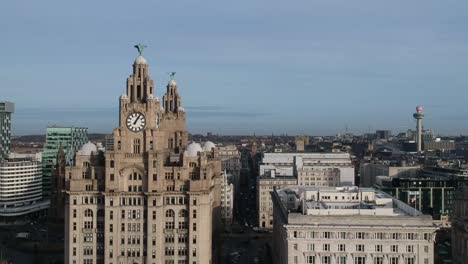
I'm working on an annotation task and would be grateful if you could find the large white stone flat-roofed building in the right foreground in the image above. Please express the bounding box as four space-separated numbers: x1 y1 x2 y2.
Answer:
272 186 437 264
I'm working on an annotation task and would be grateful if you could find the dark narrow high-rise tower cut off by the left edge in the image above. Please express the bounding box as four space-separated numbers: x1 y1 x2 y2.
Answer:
0 101 15 161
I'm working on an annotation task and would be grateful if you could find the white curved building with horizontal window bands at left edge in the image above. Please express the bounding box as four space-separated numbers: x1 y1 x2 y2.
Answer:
0 154 49 223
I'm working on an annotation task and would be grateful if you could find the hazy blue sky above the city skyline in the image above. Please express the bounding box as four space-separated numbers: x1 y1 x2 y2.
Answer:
0 0 468 135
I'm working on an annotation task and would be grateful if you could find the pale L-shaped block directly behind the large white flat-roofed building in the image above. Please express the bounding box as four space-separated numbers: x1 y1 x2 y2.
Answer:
257 153 354 228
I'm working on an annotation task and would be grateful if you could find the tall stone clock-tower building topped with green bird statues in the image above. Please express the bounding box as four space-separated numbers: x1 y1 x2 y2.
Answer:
65 46 221 264
